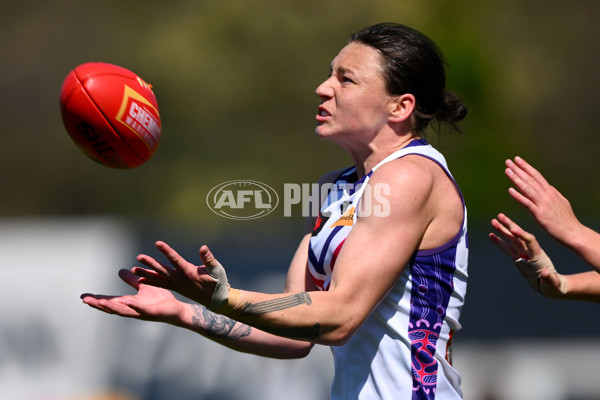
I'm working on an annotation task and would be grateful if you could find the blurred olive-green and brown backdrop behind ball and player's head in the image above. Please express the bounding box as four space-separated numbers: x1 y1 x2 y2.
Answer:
0 0 600 230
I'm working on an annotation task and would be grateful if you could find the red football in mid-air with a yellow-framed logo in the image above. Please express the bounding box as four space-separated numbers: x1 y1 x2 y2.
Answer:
60 62 161 168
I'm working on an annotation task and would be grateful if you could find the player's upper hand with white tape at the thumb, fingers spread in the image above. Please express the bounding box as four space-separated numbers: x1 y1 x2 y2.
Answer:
131 241 228 307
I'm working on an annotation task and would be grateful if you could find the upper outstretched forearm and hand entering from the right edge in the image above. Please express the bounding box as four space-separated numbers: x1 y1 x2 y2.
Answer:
505 157 600 271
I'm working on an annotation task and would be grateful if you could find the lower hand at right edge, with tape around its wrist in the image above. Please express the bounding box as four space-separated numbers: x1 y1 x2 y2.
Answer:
490 214 567 298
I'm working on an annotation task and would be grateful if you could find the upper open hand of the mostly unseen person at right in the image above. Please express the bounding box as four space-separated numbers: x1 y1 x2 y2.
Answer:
505 157 581 244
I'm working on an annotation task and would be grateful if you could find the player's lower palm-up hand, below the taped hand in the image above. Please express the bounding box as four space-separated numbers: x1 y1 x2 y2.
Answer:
81 269 183 324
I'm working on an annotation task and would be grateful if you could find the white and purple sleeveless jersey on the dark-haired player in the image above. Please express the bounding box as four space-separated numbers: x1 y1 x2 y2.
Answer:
308 139 468 400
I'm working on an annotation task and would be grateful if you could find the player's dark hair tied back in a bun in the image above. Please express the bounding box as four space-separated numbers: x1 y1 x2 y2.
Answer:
348 23 467 133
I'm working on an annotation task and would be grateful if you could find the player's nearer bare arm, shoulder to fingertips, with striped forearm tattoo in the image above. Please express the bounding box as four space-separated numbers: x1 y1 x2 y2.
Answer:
135 157 454 345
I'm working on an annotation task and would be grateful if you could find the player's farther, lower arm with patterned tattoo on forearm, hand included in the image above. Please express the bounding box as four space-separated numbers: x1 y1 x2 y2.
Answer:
86 171 339 358
